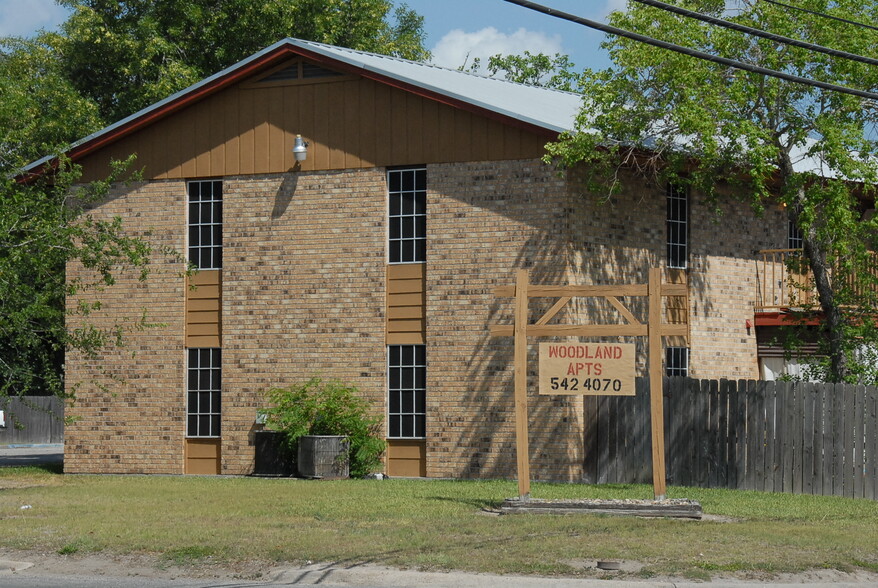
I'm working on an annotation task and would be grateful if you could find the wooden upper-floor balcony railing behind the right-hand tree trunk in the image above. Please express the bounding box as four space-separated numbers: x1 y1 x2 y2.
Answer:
755 249 878 312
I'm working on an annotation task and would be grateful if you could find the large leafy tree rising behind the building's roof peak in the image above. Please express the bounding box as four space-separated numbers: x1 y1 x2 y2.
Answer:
57 0 429 121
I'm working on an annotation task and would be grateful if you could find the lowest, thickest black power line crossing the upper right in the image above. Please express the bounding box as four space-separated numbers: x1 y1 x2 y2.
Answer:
504 0 878 100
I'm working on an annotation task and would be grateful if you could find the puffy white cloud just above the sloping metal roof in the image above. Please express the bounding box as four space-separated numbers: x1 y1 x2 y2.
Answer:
431 27 564 69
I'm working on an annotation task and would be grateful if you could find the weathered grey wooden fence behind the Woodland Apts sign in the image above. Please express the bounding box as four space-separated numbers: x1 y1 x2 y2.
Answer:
584 378 878 499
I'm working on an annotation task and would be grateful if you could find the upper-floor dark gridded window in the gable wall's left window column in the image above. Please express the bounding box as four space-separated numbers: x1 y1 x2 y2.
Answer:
188 180 223 269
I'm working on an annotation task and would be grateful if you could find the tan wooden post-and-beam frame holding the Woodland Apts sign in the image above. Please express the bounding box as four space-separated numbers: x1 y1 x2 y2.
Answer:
491 268 689 501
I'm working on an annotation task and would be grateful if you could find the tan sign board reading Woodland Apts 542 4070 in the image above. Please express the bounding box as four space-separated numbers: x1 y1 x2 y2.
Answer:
540 343 635 396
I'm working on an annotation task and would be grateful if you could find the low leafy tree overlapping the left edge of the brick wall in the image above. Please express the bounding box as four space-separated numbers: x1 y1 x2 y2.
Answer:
0 157 152 396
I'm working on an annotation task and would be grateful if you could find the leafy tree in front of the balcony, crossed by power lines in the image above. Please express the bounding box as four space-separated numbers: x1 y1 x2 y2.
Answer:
549 0 878 382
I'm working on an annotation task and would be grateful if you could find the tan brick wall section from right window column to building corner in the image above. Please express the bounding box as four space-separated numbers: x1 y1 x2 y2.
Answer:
427 161 582 480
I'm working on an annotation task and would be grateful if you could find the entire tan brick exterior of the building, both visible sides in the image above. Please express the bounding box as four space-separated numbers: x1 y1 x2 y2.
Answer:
67 160 786 481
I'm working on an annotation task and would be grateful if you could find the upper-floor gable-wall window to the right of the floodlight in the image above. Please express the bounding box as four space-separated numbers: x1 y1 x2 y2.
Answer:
387 167 427 263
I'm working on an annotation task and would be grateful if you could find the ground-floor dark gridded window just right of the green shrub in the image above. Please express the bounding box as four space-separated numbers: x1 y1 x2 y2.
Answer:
387 345 427 439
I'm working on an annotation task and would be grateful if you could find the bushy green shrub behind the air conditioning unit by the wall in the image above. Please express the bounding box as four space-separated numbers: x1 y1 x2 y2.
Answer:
264 378 386 478
